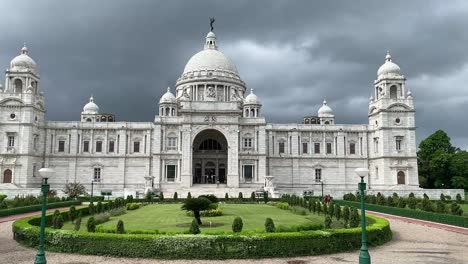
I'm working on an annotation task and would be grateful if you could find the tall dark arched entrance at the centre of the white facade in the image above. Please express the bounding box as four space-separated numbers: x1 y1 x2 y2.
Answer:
192 129 228 184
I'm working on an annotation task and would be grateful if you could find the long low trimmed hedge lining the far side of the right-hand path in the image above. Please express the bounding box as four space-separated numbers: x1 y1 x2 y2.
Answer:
335 201 468 227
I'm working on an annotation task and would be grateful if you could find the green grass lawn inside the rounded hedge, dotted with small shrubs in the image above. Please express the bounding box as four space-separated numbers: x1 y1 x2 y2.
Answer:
64 204 337 233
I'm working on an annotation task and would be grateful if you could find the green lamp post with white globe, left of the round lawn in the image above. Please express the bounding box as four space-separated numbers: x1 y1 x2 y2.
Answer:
34 168 55 264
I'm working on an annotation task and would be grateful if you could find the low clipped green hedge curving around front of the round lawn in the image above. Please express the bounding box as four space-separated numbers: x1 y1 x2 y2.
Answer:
13 207 392 259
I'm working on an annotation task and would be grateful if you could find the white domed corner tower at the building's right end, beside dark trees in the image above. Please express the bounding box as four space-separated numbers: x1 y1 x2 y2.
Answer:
368 52 419 189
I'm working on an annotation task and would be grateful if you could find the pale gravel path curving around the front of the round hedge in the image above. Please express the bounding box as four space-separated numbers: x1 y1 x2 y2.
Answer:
0 212 468 264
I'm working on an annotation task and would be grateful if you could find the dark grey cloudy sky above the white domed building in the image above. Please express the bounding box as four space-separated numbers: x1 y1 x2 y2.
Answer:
0 0 468 148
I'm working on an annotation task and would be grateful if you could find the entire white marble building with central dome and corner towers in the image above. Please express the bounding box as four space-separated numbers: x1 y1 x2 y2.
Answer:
0 27 462 200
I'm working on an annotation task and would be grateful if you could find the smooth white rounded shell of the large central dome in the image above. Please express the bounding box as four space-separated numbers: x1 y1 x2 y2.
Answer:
184 49 238 74
